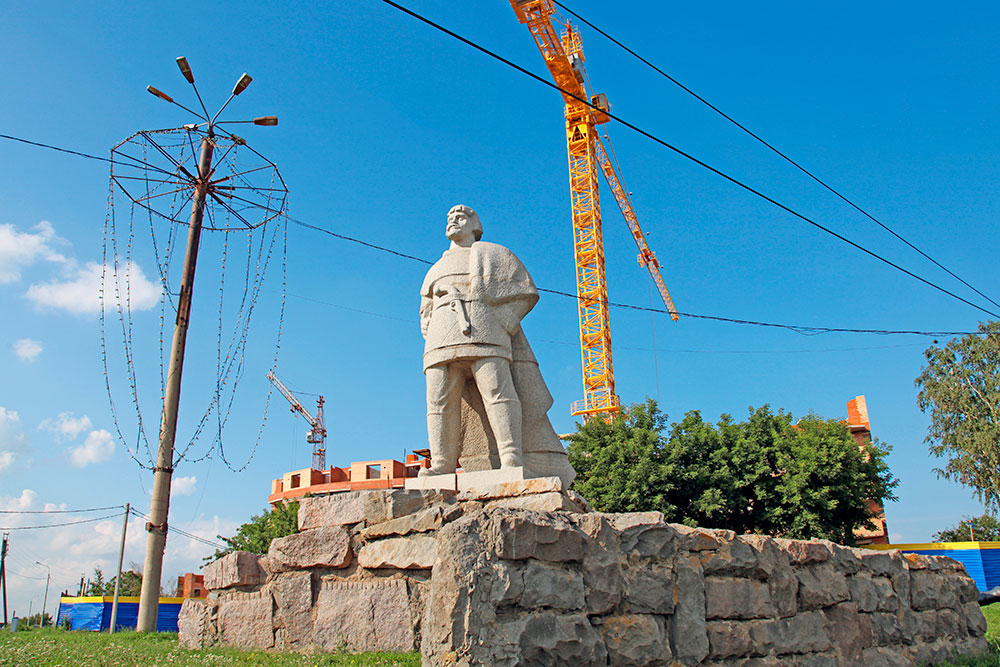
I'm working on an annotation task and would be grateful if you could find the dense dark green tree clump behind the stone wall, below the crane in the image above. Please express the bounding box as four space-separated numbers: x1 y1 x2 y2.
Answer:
569 400 897 544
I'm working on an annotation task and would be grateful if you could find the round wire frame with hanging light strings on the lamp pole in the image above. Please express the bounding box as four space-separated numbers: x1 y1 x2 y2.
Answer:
100 126 288 472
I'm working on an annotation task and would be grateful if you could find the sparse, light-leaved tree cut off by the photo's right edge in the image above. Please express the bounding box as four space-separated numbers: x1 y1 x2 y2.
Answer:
916 322 1000 510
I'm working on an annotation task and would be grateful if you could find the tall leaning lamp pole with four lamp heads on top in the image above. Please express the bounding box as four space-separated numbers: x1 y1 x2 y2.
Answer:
136 57 278 632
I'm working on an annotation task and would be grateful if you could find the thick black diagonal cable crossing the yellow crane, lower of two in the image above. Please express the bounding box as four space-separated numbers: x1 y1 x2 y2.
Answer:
382 0 1000 318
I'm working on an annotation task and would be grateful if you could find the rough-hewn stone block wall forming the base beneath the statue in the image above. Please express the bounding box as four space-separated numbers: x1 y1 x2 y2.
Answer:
178 478 986 667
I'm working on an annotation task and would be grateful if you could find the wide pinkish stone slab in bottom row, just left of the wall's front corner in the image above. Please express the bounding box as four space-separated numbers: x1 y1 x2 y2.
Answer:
313 579 416 652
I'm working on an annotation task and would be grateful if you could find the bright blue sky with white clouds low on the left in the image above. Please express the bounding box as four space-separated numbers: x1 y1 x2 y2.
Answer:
0 0 1000 613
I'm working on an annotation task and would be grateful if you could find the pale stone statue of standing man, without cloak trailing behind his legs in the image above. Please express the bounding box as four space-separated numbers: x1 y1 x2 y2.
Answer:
420 206 538 475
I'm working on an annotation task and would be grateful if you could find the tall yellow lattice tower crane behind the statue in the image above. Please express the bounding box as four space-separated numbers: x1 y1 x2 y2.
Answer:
510 0 677 421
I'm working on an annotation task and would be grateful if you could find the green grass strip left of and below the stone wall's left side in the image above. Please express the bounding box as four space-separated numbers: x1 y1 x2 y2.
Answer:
0 628 420 667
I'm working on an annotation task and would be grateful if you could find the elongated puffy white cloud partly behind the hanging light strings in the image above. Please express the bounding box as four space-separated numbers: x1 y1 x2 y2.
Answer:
25 261 161 315
